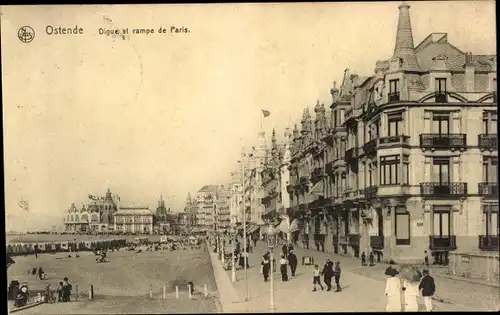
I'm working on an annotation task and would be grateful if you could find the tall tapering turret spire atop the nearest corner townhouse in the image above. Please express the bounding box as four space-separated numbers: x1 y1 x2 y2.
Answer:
393 2 421 71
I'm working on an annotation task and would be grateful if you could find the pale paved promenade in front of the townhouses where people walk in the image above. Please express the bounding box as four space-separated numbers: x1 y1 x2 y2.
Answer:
212 242 500 313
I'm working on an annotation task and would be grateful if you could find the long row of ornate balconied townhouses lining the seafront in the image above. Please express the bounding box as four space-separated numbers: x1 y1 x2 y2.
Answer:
236 3 499 263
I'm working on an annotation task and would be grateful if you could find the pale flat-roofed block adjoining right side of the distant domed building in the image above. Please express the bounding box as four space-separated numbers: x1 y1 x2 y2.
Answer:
114 207 154 234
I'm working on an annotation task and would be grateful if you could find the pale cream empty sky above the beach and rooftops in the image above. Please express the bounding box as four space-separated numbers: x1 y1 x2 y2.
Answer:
1 1 496 231
